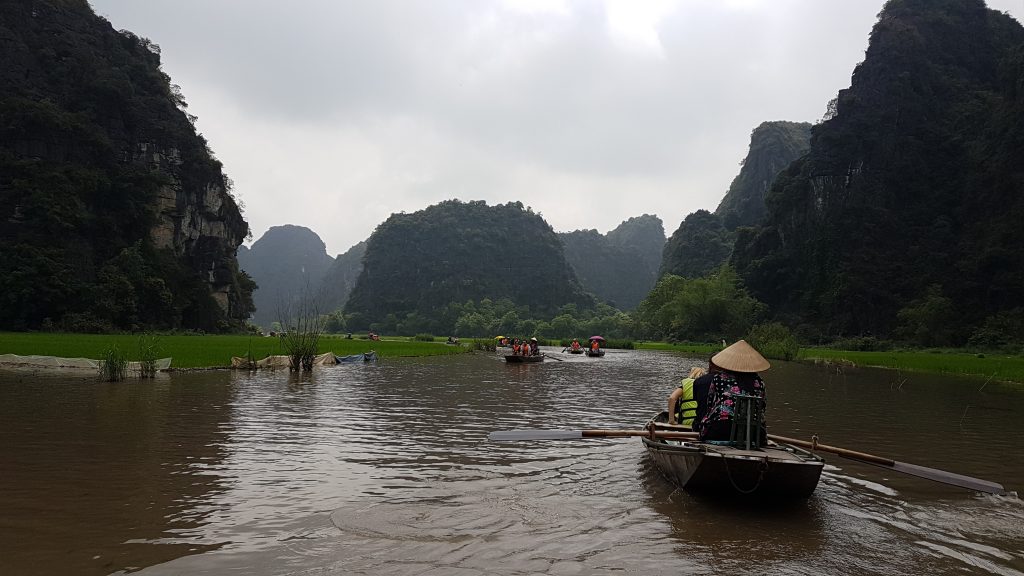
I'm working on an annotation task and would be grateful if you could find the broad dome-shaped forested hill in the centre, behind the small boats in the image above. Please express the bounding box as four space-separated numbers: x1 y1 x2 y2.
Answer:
345 200 596 336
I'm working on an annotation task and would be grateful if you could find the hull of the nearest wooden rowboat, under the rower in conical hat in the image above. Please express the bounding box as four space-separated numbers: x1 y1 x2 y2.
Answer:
643 412 824 501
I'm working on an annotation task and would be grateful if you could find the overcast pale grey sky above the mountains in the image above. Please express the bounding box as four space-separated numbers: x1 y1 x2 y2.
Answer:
90 0 1024 255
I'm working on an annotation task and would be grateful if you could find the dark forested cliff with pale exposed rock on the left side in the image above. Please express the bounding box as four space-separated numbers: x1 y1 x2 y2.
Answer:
0 0 252 330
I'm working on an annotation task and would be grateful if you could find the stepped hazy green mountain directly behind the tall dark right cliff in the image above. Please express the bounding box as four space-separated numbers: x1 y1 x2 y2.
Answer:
660 121 811 278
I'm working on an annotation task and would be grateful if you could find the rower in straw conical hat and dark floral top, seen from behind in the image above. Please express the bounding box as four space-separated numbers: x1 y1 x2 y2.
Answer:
694 340 771 442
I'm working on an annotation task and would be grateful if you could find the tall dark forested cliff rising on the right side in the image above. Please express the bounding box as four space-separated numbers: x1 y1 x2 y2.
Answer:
732 0 1024 345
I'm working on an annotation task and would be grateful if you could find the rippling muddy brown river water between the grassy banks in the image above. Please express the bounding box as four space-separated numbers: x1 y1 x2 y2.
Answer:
0 348 1024 575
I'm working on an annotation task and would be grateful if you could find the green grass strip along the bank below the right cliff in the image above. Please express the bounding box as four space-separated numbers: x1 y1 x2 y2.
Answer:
637 342 1024 383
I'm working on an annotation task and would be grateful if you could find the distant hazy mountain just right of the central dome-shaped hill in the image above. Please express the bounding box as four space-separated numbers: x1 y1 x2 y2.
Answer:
558 214 665 310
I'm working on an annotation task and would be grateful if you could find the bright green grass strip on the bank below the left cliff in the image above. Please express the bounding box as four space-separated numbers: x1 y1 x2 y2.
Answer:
0 332 467 368
